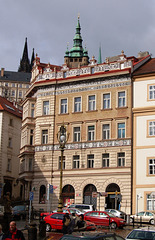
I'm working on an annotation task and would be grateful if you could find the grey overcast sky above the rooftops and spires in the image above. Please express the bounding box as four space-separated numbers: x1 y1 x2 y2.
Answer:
0 0 155 71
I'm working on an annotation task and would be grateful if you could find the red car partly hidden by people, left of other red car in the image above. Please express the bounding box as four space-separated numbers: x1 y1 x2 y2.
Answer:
44 212 96 232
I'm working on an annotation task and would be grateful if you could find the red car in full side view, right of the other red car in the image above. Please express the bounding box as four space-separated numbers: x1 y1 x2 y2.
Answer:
84 211 125 229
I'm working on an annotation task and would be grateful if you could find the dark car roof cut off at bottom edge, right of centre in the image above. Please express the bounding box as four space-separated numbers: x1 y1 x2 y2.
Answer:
60 233 124 240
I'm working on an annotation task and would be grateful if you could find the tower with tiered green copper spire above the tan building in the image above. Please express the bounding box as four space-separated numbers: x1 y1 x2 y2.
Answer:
64 17 89 68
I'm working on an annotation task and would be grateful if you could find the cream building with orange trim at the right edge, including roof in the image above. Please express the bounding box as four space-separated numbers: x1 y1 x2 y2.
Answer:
133 58 155 213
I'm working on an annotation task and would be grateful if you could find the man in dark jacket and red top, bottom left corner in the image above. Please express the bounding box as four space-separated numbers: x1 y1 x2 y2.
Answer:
2 221 25 240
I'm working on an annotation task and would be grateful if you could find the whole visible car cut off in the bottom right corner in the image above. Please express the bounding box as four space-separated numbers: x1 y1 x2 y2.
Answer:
126 227 155 240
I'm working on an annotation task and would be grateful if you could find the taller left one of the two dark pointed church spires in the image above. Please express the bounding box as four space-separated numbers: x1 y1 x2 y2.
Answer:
18 38 31 72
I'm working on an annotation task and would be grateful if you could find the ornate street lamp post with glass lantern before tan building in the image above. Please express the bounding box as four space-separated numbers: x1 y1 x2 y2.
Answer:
57 124 68 212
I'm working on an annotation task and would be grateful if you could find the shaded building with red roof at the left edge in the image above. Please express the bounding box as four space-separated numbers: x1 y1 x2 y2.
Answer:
0 96 22 199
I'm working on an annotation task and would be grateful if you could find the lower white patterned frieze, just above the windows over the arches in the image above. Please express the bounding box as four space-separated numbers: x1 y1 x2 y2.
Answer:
35 139 131 152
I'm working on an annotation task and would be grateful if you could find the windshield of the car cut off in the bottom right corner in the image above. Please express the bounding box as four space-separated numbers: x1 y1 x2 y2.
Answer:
127 230 155 240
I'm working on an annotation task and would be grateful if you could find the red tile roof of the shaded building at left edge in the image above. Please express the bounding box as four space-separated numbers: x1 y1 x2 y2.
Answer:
0 96 22 118
